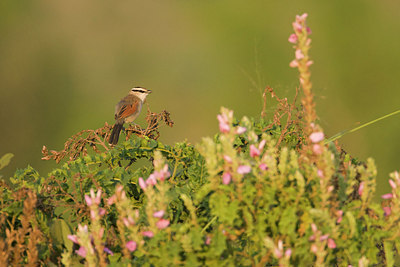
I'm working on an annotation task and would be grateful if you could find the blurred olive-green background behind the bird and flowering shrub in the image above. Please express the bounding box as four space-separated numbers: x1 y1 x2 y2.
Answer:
0 0 400 198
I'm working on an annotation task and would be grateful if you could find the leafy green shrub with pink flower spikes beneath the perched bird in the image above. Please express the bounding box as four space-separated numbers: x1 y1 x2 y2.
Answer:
0 12 400 266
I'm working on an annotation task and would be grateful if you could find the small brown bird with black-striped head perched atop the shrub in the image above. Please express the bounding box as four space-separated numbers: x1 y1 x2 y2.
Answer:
108 87 151 145
